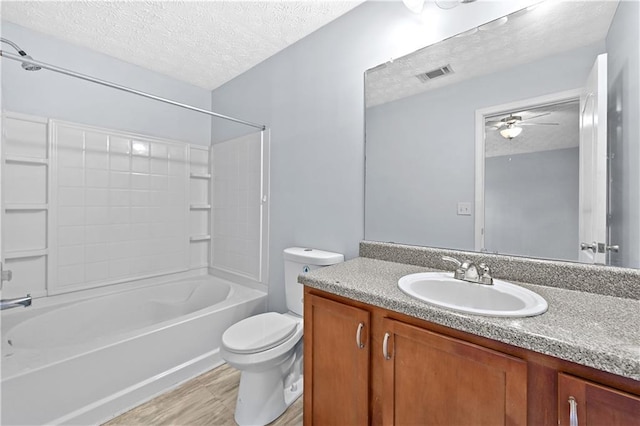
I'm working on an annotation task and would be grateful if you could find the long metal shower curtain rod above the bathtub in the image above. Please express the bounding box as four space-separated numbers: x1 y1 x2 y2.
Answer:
0 50 267 130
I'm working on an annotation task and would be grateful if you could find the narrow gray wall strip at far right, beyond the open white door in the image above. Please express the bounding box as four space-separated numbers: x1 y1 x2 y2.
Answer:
607 1 640 268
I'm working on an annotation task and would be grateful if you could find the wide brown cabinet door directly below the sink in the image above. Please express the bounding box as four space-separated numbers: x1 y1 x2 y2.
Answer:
381 319 527 426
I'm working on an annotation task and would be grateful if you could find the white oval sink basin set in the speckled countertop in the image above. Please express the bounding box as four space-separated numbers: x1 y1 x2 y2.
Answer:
398 272 547 317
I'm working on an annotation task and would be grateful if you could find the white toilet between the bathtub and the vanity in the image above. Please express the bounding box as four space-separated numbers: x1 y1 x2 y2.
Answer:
220 247 344 426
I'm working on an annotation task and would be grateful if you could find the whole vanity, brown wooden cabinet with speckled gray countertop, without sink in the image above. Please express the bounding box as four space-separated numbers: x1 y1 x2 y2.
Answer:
299 243 640 426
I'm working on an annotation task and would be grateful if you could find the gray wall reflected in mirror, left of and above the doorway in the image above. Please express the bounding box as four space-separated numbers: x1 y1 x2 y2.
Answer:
365 42 605 250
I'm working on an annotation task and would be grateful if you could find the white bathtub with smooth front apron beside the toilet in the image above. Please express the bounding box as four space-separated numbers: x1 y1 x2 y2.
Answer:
0 276 266 425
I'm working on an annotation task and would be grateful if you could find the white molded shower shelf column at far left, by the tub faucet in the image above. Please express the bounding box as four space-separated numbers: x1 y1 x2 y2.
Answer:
0 111 50 298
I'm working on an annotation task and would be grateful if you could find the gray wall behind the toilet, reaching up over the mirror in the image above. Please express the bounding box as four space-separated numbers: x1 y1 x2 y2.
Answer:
212 1 532 311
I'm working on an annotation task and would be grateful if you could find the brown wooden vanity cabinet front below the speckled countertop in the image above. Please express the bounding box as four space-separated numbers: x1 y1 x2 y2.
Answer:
304 287 640 426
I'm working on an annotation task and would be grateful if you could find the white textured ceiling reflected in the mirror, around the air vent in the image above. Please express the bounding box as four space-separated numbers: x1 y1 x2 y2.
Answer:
366 0 618 107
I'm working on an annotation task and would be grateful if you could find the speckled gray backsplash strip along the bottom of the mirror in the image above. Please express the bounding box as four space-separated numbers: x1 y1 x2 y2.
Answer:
360 241 640 300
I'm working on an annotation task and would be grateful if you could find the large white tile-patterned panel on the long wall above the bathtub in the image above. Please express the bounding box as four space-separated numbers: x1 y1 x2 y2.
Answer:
51 122 190 292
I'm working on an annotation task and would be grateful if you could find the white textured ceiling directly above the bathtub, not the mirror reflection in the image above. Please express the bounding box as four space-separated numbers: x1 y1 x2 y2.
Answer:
1 0 363 90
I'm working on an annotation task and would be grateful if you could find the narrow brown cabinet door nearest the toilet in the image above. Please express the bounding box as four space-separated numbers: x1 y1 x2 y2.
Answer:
304 294 370 426
